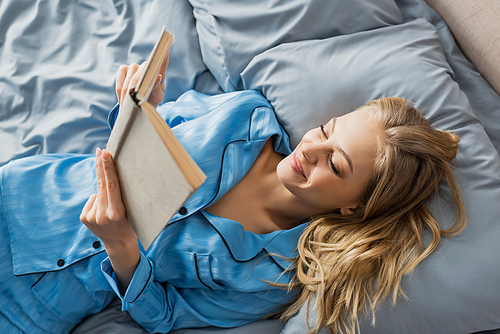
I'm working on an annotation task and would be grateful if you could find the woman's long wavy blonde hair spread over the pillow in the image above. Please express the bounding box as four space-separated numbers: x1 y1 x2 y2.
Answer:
281 98 466 333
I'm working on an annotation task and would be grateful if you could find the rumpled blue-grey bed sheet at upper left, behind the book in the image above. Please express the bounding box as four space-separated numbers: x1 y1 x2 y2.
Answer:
0 0 209 165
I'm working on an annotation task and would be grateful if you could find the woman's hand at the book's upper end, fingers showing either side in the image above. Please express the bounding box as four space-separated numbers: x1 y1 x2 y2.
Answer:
116 55 169 108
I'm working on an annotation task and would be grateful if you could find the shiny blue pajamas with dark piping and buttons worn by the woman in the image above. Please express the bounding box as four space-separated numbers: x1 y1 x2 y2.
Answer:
0 91 305 334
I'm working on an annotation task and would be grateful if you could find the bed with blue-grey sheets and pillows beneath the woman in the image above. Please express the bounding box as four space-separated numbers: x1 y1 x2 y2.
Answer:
0 0 500 334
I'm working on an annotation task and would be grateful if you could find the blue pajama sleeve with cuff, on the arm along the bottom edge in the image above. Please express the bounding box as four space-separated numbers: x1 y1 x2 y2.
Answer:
101 253 292 333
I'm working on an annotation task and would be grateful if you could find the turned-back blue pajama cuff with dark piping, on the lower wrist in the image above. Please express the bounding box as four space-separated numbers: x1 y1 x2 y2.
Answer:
101 252 153 303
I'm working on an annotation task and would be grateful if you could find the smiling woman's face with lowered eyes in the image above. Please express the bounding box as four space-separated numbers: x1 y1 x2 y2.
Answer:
277 108 382 215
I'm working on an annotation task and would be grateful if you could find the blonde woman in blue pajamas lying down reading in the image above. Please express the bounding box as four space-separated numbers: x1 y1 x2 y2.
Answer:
0 61 463 333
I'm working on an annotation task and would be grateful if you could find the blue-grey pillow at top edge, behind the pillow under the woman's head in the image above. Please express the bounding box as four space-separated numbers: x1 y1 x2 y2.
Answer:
190 0 402 92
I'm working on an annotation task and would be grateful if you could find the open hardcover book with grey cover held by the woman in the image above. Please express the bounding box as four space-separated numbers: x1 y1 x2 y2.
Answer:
107 27 205 250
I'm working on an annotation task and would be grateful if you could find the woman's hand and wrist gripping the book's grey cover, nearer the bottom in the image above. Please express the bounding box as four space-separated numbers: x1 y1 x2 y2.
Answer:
80 149 141 291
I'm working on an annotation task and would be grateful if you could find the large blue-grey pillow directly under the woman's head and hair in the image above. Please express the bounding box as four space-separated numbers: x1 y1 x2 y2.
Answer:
241 19 500 334
